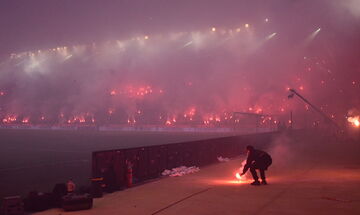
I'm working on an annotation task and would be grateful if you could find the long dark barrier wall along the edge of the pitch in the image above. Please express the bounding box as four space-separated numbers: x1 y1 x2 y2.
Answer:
92 132 278 192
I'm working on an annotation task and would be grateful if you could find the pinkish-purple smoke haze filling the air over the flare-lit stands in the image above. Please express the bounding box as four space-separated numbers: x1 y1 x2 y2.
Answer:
0 0 360 127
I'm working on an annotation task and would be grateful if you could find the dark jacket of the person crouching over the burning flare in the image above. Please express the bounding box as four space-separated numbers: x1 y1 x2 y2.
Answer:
243 149 272 173
